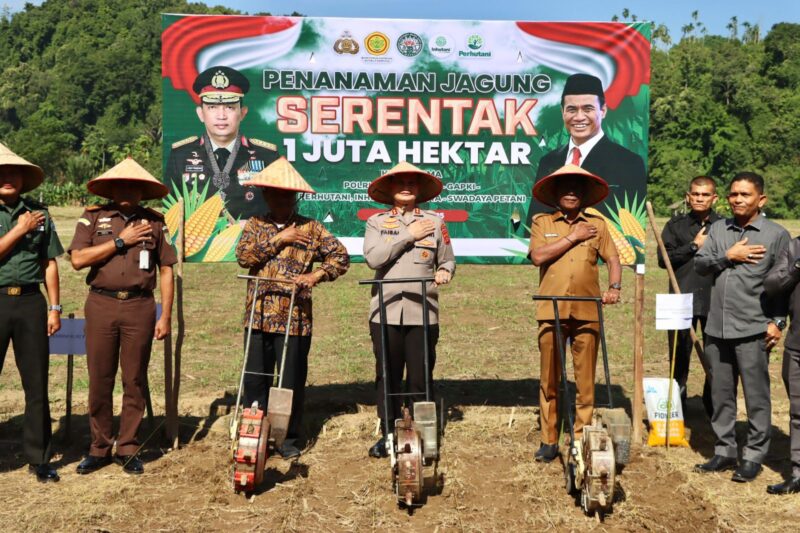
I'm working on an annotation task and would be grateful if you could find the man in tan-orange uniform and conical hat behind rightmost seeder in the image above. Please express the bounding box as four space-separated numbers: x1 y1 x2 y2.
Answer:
529 165 622 462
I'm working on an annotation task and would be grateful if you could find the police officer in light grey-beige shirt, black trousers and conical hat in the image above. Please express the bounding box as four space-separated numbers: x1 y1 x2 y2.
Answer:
364 163 456 457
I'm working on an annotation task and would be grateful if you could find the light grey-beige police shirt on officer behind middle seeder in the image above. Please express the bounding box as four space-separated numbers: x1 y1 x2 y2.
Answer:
364 208 456 326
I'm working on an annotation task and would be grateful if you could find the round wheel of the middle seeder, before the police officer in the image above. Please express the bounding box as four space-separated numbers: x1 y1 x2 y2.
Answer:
393 409 424 507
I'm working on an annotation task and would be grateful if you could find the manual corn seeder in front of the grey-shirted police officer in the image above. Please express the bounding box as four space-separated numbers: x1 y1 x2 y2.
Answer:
358 278 444 507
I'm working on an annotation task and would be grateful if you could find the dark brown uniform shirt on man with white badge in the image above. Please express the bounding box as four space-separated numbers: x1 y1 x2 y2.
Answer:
68 204 178 291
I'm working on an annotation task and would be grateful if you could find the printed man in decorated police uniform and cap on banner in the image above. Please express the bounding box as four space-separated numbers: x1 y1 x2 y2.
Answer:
166 66 278 221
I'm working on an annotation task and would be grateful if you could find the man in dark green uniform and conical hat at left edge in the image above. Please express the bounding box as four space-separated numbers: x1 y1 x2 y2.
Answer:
0 144 64 482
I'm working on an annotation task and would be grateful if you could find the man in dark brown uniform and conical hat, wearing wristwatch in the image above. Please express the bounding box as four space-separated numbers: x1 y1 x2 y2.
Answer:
68 158 177 474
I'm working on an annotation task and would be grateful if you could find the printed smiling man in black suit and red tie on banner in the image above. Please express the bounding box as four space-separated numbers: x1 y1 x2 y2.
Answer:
526 74 647 232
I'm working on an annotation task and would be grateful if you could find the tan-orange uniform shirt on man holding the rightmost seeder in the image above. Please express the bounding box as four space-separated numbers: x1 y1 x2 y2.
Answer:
530 211 617 321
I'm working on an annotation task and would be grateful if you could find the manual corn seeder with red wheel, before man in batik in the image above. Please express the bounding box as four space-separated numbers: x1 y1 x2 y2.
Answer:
230 275 304 493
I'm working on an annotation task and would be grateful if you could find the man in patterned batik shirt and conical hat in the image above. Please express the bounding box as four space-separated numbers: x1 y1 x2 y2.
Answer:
236 157 350 459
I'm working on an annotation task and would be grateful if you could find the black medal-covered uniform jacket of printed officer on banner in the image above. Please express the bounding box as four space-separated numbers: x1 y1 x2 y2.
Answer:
165 135 279 220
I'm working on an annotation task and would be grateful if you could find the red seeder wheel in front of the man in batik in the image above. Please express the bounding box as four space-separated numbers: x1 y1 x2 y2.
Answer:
233 402 269 493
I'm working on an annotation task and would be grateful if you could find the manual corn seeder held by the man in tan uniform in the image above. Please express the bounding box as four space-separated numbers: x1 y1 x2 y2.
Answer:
533 295 631 515
